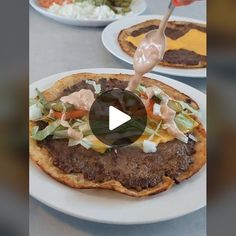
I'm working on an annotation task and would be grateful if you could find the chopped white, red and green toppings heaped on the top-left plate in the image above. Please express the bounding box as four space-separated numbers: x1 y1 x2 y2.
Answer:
39 0 135 20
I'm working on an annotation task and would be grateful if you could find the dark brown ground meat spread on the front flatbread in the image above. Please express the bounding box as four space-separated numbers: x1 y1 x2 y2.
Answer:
37 79 195 191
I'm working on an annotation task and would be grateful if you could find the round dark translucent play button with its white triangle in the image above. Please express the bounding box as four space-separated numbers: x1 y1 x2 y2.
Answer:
89 89 147 147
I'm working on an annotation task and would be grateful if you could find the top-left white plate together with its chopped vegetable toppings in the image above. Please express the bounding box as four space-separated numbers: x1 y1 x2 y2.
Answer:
30 0 146 27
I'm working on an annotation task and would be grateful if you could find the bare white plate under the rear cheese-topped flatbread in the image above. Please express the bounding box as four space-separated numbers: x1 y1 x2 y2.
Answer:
102 15 206 77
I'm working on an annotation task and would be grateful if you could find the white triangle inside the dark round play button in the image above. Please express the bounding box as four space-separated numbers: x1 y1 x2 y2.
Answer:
109 106 131 130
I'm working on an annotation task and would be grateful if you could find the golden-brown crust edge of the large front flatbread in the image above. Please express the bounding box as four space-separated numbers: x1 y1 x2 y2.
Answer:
30 73 206 197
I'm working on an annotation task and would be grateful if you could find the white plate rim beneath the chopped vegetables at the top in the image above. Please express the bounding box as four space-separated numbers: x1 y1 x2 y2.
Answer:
29 0 147 27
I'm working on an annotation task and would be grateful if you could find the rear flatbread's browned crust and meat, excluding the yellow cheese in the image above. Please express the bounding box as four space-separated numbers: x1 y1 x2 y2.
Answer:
118 20 207 68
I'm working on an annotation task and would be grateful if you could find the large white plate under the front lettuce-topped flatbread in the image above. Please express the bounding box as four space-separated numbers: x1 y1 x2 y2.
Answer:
30 69 206 224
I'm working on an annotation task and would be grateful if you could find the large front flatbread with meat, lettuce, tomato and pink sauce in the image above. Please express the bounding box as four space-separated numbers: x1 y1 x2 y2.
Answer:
30 73 206 197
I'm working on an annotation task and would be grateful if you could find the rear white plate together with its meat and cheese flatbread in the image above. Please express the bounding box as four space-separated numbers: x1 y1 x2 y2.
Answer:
102 15 207 77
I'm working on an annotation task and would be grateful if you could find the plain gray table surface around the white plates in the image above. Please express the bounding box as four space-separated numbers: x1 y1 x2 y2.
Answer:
29 0 206 236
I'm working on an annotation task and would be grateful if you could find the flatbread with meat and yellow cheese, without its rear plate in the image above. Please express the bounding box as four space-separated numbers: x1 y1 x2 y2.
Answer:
118 20 207 68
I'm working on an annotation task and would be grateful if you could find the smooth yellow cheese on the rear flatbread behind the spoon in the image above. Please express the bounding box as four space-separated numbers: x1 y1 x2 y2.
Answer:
126 29 207 56
